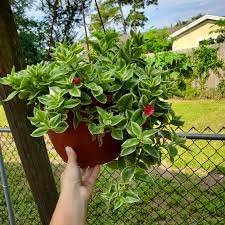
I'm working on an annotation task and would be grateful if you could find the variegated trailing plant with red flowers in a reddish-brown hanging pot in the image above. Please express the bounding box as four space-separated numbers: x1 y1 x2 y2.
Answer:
0 32 185 208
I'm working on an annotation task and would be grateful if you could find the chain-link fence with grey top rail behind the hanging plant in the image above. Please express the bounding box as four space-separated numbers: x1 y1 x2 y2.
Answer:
0 128 225 225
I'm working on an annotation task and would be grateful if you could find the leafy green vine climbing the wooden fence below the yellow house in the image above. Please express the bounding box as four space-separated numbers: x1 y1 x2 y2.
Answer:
193 45 224 90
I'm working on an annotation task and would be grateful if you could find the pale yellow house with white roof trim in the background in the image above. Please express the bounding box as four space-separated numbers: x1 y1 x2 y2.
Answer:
170 15 225 51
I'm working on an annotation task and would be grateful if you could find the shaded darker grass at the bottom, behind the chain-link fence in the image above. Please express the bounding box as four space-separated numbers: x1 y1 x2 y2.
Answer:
0 162 225 225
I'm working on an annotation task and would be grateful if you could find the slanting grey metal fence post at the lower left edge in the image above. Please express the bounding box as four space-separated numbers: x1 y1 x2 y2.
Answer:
0 146 16 225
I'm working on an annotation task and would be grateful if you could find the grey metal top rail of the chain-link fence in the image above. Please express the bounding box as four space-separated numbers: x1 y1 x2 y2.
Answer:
0 127 225 141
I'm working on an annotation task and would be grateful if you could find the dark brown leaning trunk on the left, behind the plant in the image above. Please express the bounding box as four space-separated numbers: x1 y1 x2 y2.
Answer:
0 0 58 225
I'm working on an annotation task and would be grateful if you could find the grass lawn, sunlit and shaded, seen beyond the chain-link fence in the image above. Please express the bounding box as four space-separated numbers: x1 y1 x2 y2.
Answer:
0 100 225 225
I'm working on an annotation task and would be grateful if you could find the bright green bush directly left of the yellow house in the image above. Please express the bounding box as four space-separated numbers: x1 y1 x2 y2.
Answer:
144 28 172 53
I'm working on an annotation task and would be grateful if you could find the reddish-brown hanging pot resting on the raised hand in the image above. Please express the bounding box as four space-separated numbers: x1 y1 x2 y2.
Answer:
48 113 121 167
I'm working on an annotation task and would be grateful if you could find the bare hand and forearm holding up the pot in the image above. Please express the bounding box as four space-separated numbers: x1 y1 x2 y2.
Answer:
50 147 100 225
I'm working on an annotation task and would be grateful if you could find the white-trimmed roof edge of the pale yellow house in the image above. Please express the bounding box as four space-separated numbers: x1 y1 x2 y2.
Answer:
170 15 225 38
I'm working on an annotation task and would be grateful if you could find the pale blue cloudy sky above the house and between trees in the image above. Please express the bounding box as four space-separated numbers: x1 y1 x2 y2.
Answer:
27 0 225 30
